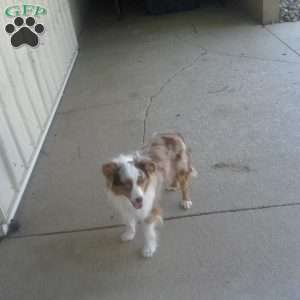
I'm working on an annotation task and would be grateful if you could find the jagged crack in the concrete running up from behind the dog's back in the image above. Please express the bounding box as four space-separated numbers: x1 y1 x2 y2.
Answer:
142 48 207 144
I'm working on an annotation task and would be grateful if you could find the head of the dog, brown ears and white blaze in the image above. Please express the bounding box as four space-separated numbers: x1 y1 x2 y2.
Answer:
102 156 156 209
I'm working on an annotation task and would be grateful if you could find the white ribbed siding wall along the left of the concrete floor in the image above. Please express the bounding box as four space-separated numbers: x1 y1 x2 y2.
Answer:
0 0 78 230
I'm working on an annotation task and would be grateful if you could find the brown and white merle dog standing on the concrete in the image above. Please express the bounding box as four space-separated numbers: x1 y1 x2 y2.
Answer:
102 133 197 257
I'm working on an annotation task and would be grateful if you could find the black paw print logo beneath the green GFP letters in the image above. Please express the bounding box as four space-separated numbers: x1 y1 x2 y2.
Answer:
5 17 45 47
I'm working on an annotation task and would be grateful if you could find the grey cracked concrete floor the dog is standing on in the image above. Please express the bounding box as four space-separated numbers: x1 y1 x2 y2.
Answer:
0 5 300 300
